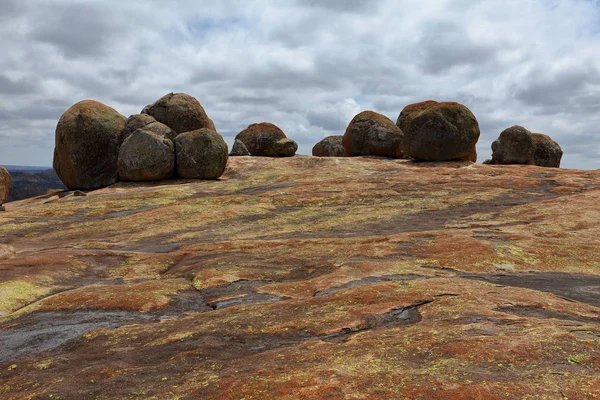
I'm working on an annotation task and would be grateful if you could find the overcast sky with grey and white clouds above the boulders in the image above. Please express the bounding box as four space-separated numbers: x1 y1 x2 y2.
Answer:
0 0 600 169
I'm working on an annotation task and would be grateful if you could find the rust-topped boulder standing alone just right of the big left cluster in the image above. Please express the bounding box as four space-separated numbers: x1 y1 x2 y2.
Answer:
235 122 298 157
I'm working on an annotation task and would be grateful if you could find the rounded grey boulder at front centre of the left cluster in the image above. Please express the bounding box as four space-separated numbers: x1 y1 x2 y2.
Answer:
118 128 175 181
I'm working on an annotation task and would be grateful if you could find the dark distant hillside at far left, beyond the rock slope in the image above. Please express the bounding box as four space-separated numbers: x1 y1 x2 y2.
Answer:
6 166 66 202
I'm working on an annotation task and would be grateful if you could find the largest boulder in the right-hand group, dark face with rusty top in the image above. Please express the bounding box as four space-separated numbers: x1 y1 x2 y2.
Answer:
396 100 480 161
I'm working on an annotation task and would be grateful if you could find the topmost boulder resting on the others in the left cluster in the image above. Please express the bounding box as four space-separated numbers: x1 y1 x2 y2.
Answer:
142 93 216 133
